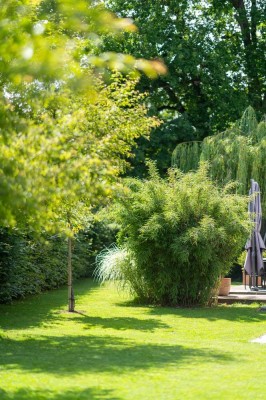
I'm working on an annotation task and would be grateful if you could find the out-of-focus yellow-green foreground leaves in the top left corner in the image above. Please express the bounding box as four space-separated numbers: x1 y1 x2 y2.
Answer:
0 0 163 89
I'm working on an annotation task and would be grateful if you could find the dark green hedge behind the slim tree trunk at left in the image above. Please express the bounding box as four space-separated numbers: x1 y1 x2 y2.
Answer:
0 222 114 303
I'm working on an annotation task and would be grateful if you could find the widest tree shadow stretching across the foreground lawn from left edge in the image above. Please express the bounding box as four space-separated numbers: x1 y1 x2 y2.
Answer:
0 335 237 375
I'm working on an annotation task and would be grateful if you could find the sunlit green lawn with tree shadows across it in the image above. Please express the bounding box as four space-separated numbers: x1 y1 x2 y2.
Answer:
0 280 266 400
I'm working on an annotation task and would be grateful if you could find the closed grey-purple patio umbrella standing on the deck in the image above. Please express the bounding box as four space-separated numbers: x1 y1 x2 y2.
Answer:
244 179 265 289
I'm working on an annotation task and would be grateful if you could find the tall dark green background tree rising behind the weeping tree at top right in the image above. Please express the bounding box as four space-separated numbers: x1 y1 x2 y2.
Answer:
104 0 266 174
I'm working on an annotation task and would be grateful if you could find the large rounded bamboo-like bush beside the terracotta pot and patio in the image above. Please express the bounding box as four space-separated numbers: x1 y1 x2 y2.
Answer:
98 164 250 306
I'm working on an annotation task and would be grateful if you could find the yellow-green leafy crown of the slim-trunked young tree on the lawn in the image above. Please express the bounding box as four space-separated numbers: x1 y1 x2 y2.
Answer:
0 74 158 231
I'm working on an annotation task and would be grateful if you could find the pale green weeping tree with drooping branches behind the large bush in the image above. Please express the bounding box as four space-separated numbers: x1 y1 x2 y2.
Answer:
172 107 266 213
